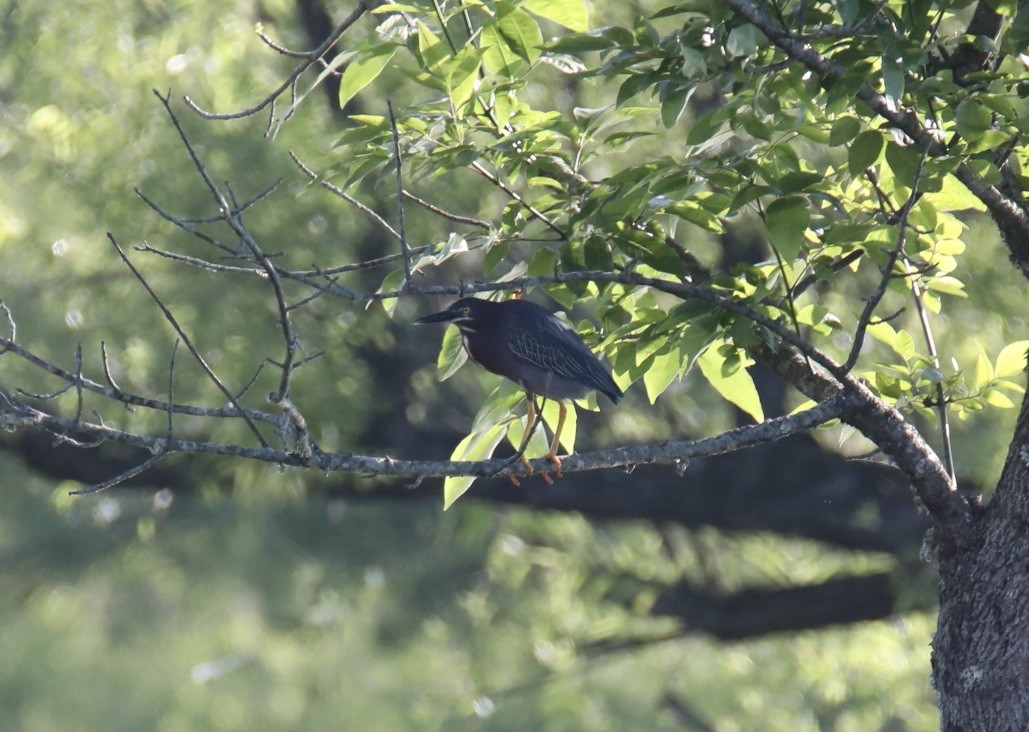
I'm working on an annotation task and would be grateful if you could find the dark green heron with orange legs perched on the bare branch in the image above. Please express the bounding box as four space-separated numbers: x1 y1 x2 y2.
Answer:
415 298 622 478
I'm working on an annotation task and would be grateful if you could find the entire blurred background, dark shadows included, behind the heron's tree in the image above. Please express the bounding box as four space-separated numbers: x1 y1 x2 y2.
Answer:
0 0 1024 730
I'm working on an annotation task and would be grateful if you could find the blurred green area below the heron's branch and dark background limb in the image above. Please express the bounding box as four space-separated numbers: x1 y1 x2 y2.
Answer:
0 457 935 732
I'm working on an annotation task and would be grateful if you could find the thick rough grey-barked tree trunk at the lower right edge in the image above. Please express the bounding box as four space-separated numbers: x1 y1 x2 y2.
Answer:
932 382 1029 732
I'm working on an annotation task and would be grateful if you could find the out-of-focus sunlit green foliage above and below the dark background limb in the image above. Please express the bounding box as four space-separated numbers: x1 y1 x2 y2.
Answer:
0 0 1025 731
